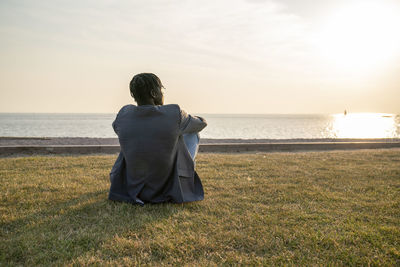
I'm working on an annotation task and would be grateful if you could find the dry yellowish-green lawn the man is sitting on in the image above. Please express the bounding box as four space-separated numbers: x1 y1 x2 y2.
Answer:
0 149 400 266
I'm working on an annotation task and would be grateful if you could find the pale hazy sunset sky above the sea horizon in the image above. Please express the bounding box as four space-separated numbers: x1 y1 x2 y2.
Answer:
0 0 400 114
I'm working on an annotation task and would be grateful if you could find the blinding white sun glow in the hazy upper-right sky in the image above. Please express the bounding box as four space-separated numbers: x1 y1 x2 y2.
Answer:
316 1 400 74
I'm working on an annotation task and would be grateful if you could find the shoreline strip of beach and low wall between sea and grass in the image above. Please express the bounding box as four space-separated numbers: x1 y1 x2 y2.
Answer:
0 137 400 156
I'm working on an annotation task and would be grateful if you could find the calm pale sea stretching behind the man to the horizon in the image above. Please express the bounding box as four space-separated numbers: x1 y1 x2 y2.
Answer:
0 113 400 139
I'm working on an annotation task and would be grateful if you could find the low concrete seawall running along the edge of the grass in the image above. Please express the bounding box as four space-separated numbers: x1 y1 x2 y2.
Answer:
0 142 400 156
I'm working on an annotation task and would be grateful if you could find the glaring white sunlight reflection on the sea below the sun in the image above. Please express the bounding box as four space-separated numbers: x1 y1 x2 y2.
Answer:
327 113 399 138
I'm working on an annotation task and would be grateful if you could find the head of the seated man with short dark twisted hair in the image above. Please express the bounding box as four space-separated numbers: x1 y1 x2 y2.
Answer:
129 73 164 106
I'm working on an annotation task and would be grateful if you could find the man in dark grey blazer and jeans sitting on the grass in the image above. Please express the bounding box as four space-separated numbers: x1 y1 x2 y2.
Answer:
109 73 207 205
